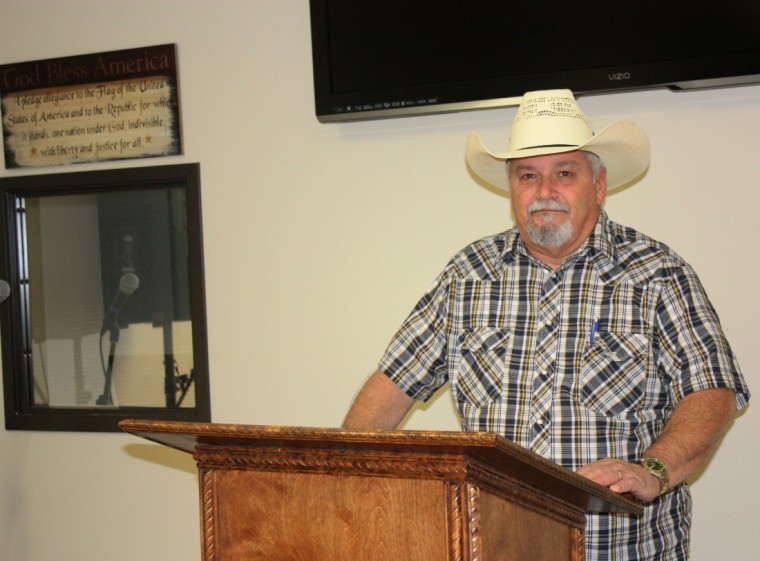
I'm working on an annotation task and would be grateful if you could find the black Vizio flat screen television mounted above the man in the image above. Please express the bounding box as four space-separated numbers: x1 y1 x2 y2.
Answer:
310 0 760 122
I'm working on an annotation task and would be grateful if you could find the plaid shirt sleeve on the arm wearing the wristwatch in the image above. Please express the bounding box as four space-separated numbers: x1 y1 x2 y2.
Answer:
657 264 750 409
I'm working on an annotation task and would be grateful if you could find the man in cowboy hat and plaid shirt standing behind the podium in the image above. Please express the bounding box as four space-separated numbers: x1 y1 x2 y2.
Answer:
344 90 749 561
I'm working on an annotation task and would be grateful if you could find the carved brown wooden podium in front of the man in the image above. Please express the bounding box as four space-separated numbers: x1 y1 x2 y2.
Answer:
121 420 642 561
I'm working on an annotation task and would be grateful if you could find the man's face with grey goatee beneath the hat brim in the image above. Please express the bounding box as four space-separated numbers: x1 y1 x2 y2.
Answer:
509 150 607 267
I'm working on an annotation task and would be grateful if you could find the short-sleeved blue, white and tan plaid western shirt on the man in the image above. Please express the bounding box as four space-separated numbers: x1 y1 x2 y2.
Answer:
379 211 749 561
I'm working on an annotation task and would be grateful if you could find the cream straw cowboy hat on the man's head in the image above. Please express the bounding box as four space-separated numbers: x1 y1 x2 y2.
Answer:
465 90 649 190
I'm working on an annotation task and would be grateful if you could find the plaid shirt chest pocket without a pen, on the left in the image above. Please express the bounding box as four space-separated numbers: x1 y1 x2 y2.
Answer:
451 327 510 407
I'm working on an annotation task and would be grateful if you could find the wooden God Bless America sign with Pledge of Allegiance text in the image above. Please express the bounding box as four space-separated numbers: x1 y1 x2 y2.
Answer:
0 45 182 168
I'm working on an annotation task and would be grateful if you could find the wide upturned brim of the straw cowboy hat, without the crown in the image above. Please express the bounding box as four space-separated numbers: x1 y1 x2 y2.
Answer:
465 121 650 191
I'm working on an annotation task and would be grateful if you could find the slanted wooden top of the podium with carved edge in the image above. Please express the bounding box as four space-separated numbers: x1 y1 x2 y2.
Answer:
119 419 643 515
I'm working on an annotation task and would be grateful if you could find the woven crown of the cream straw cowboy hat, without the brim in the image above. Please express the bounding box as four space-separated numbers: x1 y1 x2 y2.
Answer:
509 90 594 152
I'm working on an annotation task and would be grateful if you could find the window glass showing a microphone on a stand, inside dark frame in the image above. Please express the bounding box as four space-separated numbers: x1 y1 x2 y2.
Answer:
25 189 195 407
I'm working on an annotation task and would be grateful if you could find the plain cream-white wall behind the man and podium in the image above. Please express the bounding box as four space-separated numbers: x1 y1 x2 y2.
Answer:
0 0 760 561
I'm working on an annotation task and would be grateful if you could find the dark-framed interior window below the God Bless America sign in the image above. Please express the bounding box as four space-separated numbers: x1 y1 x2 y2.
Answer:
0 164 211 432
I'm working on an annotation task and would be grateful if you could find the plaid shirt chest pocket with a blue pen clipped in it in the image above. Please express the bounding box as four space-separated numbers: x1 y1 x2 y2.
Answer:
580 331 649 416
